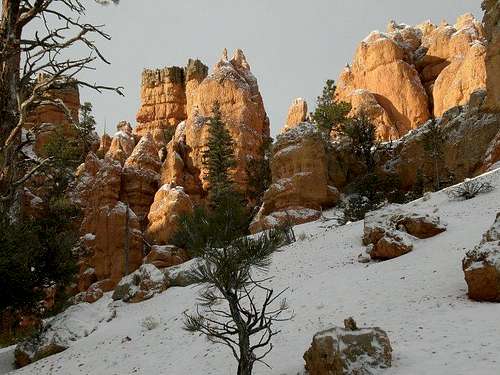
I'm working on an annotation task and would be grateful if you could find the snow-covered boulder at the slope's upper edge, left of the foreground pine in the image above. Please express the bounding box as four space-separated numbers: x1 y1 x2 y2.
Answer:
112 264 169 303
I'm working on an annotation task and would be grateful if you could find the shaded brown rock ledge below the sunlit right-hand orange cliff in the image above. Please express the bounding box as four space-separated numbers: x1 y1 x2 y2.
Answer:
381 95 500 190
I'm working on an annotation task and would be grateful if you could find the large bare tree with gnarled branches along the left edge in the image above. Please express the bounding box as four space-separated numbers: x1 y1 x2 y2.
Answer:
0 0 122 217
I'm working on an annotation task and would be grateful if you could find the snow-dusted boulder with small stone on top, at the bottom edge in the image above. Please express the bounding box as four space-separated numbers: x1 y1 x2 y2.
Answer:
304 318 392 375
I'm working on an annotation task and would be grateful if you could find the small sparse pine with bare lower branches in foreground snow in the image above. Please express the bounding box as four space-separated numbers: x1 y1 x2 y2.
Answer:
185 232 291 375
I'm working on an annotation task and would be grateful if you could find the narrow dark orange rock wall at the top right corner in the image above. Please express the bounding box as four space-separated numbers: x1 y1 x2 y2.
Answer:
482 0 500 112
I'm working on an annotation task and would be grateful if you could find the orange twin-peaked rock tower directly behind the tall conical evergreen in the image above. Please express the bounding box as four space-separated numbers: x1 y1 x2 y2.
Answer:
184 50 269 197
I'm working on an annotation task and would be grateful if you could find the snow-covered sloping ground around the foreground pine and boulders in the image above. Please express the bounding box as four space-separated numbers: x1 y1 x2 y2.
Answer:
0 170 500 375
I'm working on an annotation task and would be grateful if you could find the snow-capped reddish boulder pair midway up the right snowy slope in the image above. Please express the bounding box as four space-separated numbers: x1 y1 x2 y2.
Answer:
363 205 446 259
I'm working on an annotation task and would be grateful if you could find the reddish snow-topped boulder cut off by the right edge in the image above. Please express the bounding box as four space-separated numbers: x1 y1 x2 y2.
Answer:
462 213 500 302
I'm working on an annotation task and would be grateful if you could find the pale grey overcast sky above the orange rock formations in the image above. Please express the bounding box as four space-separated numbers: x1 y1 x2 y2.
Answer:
75 0 482 135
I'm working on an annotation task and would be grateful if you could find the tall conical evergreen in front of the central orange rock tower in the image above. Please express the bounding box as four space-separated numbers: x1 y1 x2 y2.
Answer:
203 101 236 207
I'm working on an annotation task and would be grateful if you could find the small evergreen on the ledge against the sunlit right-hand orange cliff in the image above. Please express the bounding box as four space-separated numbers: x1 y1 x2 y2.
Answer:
311 79 351 134
